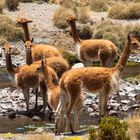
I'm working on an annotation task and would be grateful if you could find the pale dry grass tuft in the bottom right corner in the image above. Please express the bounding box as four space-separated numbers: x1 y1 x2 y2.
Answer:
126 115 140 140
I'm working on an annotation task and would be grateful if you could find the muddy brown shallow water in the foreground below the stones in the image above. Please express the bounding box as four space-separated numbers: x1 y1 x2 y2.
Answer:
0 111 97 133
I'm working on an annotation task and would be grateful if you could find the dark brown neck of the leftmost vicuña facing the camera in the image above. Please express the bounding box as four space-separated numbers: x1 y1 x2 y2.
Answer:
5 54 15 74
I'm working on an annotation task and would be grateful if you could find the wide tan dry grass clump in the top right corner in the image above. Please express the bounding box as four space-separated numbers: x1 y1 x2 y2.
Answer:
108 2 140 19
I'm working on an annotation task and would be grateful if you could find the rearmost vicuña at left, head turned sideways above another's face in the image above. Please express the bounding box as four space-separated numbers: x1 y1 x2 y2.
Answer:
16 18 62 61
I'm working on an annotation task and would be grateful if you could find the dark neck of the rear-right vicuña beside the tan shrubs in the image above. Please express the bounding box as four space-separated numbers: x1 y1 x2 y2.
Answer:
70 22 80 44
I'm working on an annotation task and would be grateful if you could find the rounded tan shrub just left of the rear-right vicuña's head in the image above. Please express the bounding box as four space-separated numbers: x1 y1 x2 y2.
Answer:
53 7 75 29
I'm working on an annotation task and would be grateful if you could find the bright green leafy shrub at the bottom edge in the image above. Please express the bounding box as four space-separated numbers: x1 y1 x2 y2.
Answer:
99 117 130 140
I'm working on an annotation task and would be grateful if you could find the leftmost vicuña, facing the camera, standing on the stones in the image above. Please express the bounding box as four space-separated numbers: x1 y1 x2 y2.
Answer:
3 44 57 112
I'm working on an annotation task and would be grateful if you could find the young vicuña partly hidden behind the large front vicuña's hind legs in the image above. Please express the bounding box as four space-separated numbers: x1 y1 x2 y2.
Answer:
37 60 83 129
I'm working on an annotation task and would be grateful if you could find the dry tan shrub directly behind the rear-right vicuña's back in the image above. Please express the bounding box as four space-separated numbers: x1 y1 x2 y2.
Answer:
93 20 127 49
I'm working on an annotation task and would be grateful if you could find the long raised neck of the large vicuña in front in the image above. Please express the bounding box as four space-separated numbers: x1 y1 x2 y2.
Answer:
115 42 131 72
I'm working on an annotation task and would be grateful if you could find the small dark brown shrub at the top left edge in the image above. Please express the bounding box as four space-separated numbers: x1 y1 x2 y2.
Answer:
6 0 19 11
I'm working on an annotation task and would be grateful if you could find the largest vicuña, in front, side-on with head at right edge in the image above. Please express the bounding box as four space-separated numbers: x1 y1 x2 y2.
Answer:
56 35 140 132
